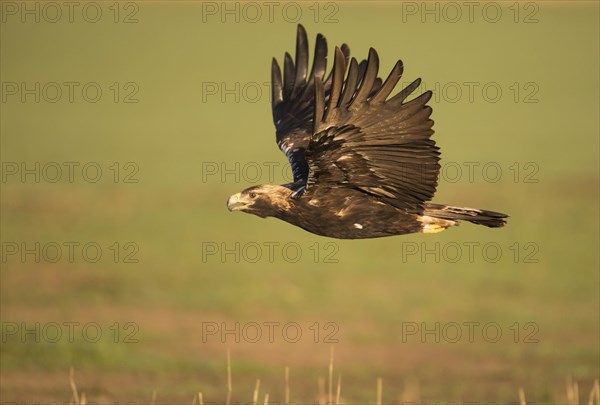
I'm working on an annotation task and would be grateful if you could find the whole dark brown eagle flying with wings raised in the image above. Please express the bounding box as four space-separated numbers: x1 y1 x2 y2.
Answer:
227 25 507 239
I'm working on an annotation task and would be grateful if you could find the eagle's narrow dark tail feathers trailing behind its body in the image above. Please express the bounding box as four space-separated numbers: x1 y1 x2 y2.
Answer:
423 204 508 228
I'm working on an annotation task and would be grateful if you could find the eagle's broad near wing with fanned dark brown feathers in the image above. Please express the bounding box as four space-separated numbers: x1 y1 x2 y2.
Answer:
305 48 440 212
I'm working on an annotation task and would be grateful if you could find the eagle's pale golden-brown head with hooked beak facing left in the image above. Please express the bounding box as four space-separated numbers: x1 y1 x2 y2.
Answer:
227 184 292 218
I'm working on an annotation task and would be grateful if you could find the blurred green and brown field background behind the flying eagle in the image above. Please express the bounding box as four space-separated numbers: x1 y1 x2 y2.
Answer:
0 1 600 403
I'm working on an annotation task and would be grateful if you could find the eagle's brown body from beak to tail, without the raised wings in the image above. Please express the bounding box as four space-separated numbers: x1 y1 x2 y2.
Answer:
228 185 506 239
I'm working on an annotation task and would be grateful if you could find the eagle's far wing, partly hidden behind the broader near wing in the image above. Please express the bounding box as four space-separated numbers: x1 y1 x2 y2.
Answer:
271 25 381 184
